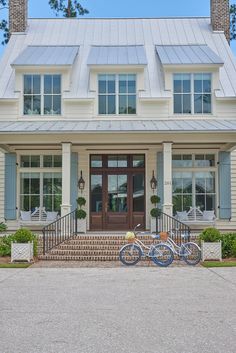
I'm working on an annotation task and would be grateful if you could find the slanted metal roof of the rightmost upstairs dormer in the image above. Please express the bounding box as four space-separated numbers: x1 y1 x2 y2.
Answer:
156 45 223 65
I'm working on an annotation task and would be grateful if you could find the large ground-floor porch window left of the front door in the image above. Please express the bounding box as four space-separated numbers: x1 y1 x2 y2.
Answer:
20 155 62 216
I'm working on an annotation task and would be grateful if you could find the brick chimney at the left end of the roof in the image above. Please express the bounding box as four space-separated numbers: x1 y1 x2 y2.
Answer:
9 0 28 34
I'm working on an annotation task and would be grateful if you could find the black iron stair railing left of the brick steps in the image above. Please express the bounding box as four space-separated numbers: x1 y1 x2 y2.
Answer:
43 210 77 255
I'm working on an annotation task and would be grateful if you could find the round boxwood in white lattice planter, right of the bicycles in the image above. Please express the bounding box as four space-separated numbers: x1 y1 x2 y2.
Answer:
200 228 222 261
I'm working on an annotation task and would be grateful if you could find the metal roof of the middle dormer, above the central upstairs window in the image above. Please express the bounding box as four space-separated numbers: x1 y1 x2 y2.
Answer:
88 45 147 65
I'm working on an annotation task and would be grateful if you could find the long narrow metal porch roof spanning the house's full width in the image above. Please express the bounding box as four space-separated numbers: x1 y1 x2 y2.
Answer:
0 119 236 134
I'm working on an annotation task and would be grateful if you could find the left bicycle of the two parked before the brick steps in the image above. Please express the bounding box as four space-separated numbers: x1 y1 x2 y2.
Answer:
119 224 174 267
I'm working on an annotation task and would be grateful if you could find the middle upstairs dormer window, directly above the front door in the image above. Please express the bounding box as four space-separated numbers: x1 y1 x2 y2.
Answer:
98 74 136 115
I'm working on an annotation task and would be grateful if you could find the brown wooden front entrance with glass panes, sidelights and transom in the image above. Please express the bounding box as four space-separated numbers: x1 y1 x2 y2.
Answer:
90 155 145 231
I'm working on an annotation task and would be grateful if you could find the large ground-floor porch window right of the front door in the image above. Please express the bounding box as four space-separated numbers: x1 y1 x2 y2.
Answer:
172 154 216 213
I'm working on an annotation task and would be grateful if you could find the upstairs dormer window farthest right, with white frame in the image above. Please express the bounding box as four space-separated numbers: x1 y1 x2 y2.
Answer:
174 73 212 114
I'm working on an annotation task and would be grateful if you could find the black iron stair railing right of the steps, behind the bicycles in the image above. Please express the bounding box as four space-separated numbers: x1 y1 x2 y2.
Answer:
156 211 191 244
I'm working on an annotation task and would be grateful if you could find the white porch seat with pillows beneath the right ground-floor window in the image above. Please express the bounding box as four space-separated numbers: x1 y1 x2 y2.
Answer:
176 207 216 225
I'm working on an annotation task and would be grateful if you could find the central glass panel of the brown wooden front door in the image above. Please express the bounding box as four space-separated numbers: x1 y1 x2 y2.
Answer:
108 175 128 212
